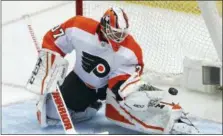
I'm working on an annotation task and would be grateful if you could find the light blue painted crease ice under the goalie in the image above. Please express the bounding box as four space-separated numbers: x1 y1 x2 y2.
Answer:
2 101 222 134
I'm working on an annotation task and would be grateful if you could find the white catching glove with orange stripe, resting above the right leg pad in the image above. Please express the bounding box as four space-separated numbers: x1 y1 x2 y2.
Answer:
118 69 164 111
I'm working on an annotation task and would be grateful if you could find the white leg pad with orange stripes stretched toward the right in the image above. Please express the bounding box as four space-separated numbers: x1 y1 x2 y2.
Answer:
106 90 182 134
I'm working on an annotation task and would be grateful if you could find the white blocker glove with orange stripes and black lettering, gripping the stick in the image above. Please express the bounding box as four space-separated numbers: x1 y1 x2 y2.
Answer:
26 49 69 95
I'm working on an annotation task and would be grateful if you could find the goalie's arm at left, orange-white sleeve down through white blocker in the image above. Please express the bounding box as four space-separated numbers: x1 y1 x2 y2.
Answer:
27 16 83 94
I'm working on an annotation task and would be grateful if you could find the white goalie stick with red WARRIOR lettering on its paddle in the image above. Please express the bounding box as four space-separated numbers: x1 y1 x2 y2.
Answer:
23 15 77 134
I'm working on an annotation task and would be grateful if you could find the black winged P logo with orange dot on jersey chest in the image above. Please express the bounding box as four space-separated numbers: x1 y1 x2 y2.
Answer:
82 52 110 78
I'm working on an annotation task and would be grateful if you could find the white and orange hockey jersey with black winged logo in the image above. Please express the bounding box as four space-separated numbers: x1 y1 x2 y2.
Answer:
42 16 143 88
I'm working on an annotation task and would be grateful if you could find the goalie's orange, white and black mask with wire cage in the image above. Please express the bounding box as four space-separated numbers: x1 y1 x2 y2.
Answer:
100 8 129 43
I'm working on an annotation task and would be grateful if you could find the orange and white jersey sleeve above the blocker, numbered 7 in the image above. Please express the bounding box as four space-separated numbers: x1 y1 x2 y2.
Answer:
42 17 76 56
